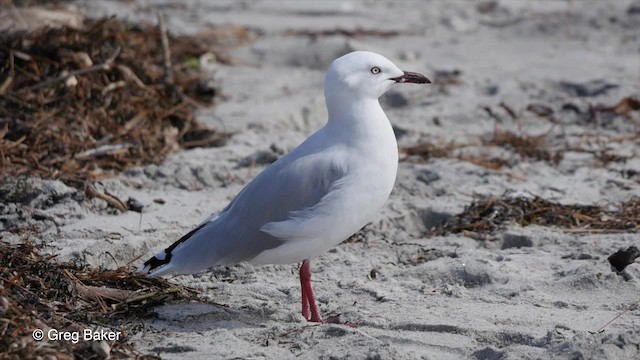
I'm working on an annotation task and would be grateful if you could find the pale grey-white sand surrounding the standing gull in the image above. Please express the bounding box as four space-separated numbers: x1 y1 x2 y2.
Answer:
11 0 640 359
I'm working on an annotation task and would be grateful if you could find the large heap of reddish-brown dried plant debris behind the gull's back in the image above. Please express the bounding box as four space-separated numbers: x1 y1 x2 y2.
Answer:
0 18 247 183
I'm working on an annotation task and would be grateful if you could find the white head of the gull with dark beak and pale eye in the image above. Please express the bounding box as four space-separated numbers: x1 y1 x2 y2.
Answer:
324 51 431 101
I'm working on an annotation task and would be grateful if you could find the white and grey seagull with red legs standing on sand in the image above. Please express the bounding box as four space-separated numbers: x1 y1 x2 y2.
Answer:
140 51 431 323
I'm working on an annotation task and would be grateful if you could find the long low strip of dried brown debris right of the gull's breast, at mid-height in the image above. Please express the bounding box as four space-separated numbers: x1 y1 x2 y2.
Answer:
429 192 640 239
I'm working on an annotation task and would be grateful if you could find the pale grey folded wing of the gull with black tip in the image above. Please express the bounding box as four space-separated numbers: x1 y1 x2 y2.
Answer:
142 151 347 275
